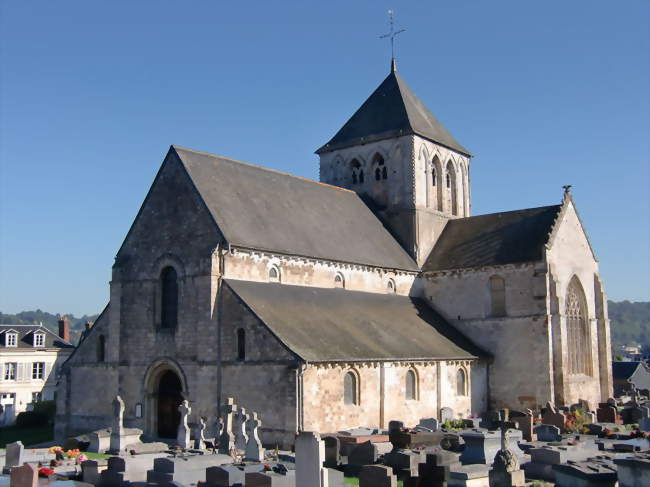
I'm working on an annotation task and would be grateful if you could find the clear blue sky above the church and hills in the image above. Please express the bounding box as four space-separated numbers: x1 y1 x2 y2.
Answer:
0 0 650 314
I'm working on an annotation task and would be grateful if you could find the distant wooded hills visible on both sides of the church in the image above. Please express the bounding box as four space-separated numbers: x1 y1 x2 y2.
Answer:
0 301 650 348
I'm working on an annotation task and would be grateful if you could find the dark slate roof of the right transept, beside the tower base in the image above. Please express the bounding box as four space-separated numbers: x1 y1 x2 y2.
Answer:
422 205 562 271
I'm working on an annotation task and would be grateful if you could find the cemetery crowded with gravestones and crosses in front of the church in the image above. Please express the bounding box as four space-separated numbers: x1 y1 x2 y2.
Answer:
0 390 650 487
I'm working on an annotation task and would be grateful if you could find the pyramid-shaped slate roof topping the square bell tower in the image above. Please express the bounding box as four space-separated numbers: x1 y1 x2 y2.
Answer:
316 64 471 156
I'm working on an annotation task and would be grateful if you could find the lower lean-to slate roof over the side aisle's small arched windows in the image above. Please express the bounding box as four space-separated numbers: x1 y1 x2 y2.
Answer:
225 279 485 362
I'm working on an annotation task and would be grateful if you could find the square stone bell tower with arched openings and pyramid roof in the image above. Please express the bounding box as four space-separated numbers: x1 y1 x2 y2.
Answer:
316 59 472 265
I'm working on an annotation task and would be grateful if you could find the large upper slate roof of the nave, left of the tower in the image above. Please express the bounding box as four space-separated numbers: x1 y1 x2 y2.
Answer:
170 146 417 270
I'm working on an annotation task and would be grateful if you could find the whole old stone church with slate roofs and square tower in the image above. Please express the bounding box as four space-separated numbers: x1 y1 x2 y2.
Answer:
56 62 612 445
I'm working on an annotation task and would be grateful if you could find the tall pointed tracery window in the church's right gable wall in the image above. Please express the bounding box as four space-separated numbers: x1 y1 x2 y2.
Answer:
564 276 592 375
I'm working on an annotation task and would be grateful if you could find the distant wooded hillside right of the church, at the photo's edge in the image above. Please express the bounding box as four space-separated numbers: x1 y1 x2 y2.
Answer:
608 301 650 348
